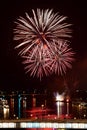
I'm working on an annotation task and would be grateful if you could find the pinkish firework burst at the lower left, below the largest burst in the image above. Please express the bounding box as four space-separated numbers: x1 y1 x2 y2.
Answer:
22 45 51 79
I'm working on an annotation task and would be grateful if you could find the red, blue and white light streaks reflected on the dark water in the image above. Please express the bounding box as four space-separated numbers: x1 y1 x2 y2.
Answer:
3 94 70 119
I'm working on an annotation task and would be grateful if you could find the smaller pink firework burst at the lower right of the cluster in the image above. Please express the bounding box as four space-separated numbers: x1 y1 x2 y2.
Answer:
50 41 75 75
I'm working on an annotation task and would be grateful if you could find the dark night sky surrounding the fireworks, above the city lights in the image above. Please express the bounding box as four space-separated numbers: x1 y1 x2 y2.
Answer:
0 0 87 91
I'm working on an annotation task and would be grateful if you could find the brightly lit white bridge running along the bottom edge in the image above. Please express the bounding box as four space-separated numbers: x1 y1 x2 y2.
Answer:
0 119 87 129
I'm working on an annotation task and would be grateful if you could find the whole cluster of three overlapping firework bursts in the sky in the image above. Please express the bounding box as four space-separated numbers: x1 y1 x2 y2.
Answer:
14 9 74 79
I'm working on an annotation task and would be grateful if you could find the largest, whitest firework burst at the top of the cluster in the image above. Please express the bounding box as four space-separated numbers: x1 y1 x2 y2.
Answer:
14 9 71 55
